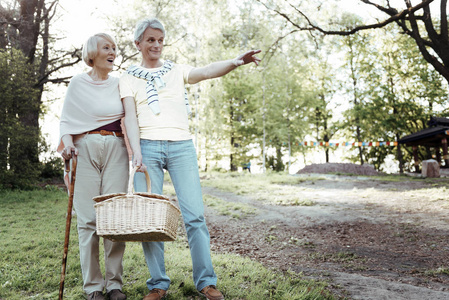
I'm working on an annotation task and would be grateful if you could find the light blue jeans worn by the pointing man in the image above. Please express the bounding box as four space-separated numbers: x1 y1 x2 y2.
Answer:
134 139 217 290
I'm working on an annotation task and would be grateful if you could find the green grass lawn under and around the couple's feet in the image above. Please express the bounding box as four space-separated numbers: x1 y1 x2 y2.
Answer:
0 182 333 300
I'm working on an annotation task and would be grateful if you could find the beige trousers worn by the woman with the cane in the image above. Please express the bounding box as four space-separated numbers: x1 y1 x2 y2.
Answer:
73 134 129 294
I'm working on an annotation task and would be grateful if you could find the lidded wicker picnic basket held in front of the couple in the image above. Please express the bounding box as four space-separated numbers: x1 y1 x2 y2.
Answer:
93 168 181 242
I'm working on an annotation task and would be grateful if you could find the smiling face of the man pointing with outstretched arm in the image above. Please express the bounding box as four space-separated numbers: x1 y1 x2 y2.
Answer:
136 27 165 62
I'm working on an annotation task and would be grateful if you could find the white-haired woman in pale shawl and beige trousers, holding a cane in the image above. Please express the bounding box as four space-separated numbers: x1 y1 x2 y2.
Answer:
58 33 129 300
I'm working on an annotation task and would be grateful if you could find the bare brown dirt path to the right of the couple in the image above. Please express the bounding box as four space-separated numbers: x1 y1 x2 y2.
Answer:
203 175 449 300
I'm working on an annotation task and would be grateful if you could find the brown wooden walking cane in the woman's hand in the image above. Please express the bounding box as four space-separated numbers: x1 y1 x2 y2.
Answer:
59 151 77 300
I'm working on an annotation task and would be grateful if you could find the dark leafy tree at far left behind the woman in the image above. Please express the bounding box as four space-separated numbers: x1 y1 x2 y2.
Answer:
0 0 81 186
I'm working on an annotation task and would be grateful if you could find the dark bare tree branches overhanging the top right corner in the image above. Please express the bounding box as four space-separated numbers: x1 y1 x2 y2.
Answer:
256 0 449 82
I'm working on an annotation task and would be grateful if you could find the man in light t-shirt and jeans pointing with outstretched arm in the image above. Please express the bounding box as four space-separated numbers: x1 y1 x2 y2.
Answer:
120 19 260 300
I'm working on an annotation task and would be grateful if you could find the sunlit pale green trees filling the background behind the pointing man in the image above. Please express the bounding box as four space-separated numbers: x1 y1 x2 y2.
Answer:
107 0 449 171
